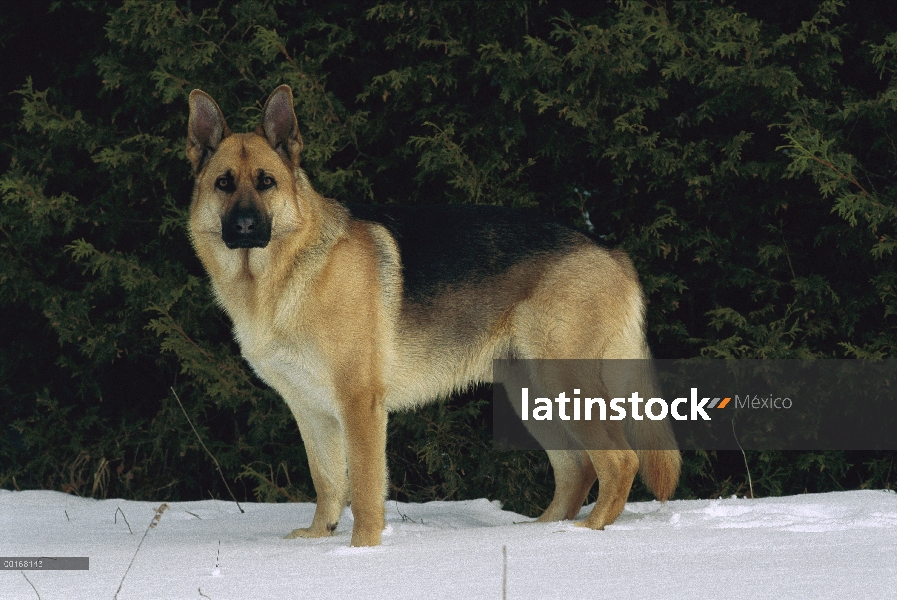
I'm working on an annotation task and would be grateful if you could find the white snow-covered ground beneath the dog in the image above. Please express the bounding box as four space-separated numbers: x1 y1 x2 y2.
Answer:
0 490 897 600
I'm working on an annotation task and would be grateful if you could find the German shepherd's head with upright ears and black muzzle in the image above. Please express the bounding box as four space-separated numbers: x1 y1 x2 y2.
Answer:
187 85 302 250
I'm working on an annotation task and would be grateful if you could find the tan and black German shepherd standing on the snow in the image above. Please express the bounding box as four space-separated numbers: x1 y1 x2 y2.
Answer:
187 85 681 546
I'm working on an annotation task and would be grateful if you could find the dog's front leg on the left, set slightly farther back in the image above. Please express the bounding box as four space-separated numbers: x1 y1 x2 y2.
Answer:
286 410 349 539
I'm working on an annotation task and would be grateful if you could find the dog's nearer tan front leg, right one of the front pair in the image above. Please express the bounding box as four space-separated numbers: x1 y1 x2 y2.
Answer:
343 392 386 546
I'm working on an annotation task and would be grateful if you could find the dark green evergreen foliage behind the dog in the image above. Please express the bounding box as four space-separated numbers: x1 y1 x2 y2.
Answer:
0 0 897 513
